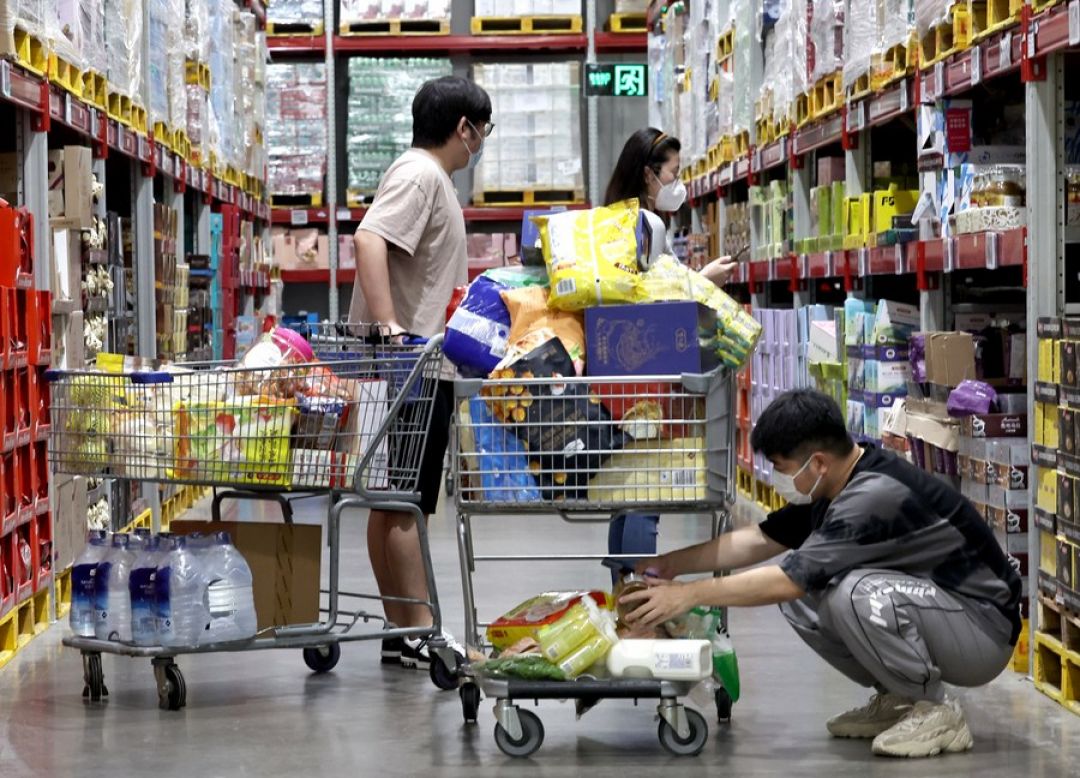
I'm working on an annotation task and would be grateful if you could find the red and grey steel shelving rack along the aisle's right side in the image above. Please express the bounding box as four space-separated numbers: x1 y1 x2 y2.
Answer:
650 0 1080 700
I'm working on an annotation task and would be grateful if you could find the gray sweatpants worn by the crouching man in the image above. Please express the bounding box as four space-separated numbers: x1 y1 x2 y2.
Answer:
780 569 1013 702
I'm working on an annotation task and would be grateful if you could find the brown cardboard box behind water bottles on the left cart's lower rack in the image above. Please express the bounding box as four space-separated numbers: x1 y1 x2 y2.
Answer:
168 520 323 630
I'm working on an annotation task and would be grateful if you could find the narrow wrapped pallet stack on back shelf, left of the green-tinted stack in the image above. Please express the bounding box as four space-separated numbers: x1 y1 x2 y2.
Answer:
266 63 326 205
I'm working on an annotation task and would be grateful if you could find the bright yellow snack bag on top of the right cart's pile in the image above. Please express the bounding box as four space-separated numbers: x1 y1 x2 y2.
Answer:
534 200 647 311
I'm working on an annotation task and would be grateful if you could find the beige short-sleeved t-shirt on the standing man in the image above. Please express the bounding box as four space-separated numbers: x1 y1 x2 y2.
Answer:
349 149 469 337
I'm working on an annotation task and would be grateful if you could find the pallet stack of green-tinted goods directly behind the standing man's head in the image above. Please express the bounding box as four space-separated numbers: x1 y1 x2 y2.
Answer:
345 57 449 205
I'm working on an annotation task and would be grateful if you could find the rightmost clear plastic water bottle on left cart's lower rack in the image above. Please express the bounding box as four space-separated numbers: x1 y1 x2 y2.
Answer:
203 532 257 643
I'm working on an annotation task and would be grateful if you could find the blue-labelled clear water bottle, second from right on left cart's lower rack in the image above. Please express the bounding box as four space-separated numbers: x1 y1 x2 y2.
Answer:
154 536 210 647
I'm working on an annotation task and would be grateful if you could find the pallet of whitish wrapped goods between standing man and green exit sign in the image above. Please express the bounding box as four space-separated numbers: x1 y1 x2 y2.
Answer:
473 63 584 205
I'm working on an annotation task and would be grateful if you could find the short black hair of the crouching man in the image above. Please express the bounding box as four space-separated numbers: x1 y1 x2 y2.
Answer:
750 389 855 459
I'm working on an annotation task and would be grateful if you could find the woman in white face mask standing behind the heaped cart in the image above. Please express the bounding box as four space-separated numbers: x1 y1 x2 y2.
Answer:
604 128 735 571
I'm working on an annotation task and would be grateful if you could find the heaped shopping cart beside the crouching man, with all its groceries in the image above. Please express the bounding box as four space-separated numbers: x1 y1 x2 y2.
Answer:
445 201 760 756
